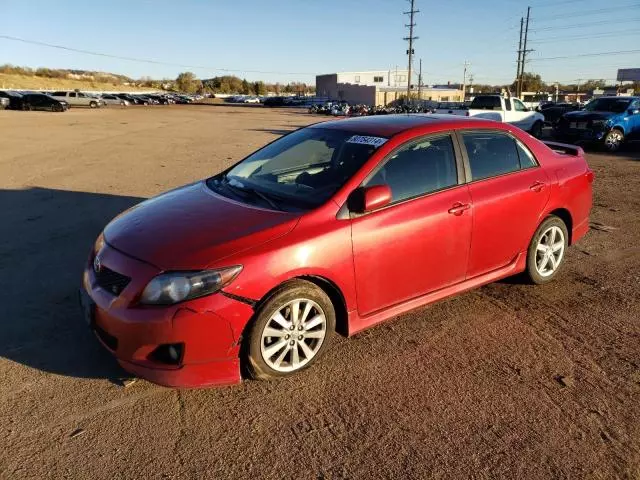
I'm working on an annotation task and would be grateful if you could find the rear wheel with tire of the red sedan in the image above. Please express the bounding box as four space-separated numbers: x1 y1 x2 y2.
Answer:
525 215 569 285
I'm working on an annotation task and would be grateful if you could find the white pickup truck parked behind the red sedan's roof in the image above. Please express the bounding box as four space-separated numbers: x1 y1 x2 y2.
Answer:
444 95 544 138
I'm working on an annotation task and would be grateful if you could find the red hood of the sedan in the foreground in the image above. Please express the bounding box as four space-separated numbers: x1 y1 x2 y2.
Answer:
104 182 299 270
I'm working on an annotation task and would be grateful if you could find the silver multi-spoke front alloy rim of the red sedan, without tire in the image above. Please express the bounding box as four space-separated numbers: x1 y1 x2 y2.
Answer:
260 298 327 372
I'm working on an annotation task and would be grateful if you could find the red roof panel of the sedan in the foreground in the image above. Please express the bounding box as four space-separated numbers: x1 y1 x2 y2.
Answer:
310 113 502 137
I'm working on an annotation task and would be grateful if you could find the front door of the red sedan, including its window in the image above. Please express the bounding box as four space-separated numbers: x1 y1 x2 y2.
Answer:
351 134 471 316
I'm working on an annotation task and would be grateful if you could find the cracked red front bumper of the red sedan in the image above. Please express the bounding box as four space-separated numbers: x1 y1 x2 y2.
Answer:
83 245 253 388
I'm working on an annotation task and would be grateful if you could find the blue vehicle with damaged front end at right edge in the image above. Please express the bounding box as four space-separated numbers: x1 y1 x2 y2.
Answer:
553 97 640 152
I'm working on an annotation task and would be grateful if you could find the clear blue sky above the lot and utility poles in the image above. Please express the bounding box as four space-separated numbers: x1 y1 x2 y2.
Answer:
0 0 640 84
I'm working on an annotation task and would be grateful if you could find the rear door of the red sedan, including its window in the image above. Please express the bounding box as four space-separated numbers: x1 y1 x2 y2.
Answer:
459 130 550 278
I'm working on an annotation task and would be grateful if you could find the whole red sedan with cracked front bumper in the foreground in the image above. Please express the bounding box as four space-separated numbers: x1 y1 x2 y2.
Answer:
81 115 593 387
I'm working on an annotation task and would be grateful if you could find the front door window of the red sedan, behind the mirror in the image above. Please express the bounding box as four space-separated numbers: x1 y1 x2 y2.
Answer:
365 135 458 202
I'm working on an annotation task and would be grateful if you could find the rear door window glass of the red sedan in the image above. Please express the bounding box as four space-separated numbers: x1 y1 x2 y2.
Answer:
462 132 520 181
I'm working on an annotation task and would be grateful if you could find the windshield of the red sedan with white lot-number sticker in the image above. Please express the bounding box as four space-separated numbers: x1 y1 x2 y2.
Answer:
208 128 387 210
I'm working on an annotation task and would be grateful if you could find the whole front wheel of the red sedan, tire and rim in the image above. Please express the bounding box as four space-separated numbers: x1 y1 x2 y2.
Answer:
242 280 336 380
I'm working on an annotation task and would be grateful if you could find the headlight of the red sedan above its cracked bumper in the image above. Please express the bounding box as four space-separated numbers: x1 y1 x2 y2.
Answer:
140 265 242 305
